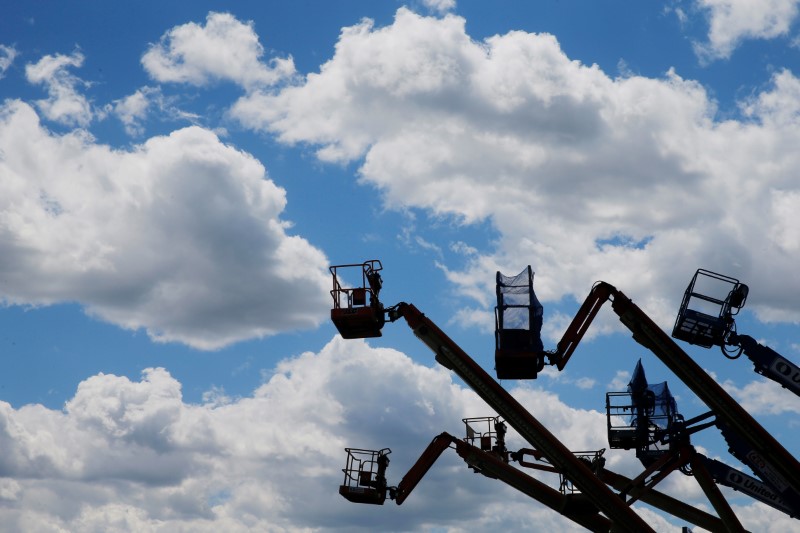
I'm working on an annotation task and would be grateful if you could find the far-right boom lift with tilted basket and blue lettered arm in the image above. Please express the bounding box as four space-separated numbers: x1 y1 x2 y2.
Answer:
672 268 800 395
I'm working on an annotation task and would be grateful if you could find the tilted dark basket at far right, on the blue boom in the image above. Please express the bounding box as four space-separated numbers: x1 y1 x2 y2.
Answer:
672 268 748 348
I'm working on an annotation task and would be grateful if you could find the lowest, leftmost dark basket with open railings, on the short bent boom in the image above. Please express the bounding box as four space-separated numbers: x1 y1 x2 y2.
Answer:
339 448 392 505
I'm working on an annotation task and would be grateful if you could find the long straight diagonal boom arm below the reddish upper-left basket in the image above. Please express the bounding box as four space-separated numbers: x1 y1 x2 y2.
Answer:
389 303 653 532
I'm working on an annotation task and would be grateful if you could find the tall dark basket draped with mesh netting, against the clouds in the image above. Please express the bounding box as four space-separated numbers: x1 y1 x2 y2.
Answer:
494 265 544 379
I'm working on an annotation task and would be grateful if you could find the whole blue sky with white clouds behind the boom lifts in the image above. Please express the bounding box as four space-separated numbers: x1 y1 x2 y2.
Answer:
0 0 800 531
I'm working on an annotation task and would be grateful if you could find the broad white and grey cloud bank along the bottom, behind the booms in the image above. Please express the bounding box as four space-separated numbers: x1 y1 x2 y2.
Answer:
0 337 791 531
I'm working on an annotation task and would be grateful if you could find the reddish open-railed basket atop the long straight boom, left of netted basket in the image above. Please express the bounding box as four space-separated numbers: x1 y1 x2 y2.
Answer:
330 259 386 339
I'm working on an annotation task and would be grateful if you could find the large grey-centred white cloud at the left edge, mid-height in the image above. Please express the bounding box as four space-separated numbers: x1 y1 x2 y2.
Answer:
0 101 329 349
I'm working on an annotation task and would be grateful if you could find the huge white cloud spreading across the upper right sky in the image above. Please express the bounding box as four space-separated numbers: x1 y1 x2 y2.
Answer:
232 9 800 328
